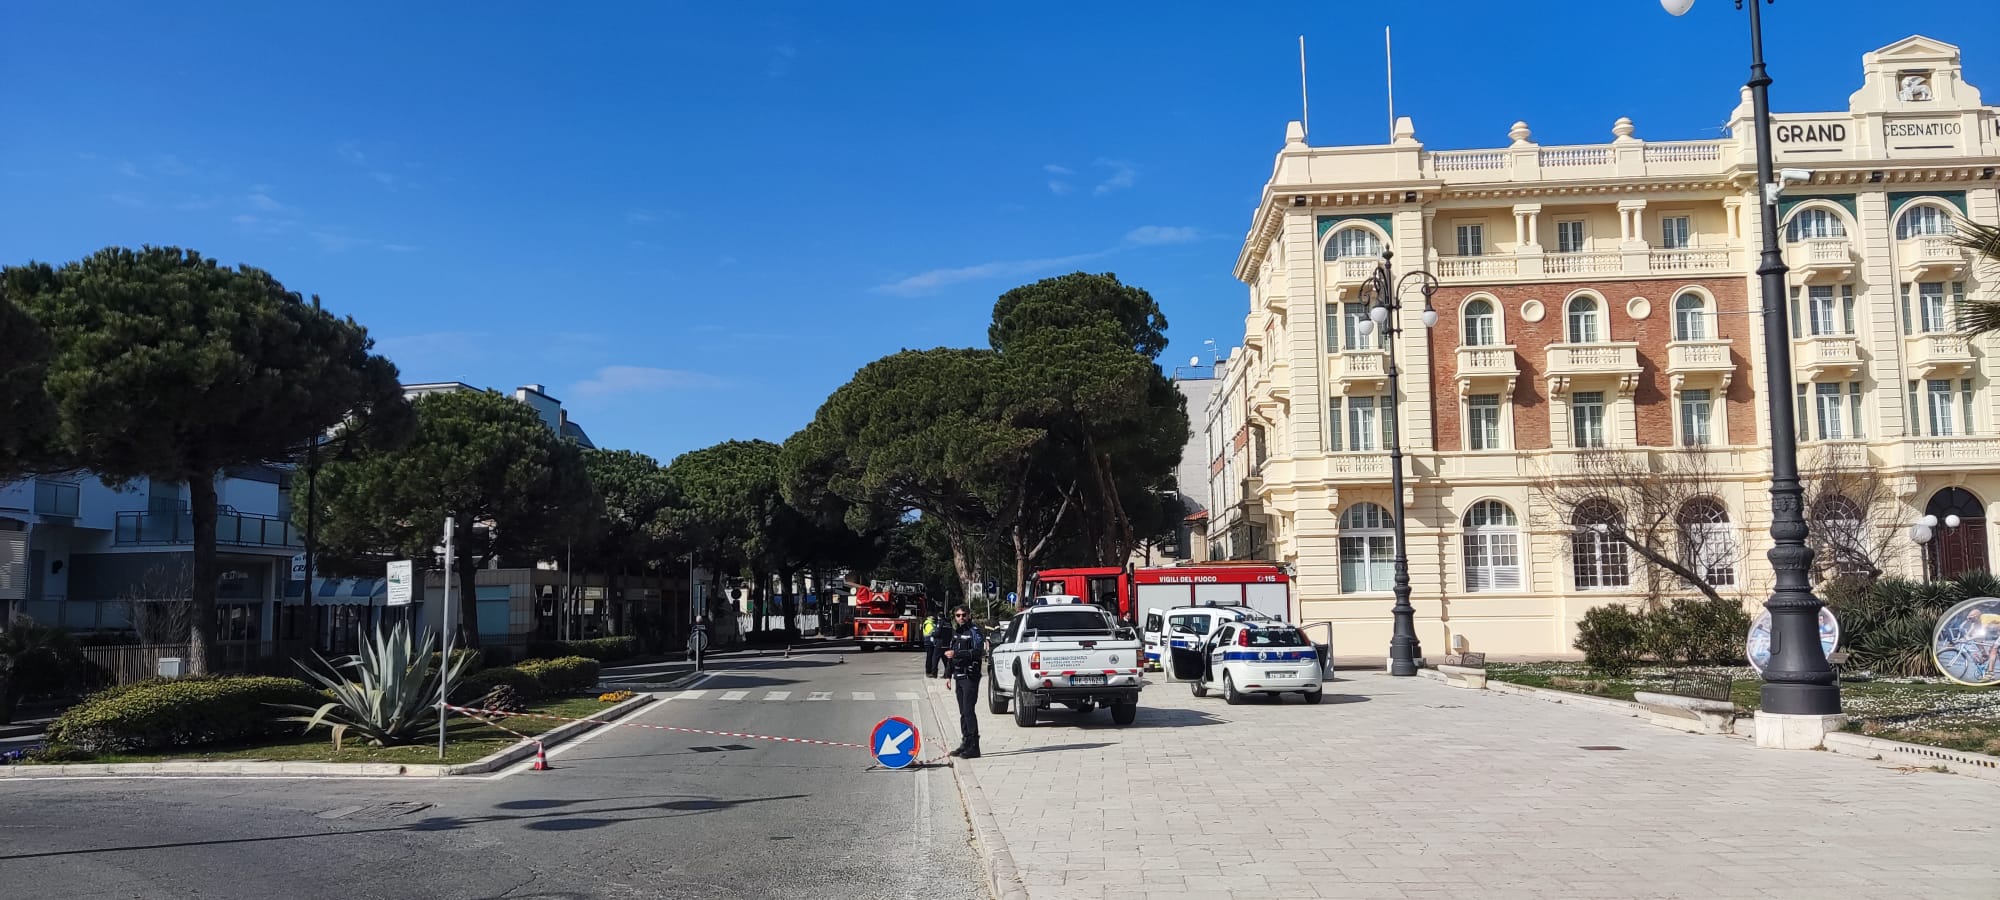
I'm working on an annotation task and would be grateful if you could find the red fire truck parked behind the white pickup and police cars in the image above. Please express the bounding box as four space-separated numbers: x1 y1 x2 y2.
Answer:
1030 560 1294 622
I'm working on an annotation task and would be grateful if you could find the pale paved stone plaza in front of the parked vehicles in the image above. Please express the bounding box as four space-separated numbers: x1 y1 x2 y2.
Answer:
932 672 2000 900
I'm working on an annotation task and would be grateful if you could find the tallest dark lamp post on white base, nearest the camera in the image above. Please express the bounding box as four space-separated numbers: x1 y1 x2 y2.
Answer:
1660 0 1840 732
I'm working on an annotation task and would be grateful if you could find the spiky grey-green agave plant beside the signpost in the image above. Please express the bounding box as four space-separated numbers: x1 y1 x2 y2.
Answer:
286 622 472 750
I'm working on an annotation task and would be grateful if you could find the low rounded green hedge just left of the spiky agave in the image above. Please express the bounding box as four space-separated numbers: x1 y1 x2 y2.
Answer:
48 676 326 754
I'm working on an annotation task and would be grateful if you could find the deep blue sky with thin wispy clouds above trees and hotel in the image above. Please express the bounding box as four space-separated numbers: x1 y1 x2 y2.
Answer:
0 0 2000 460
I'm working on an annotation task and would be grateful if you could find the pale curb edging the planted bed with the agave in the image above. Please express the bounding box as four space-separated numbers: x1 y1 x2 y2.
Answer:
0 694 654 778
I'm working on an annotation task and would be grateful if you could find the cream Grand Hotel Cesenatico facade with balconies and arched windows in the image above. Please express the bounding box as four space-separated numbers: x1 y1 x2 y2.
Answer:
1206 36 2000 658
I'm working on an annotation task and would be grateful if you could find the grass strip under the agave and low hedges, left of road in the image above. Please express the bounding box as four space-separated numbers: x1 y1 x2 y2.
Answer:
41 694 632 766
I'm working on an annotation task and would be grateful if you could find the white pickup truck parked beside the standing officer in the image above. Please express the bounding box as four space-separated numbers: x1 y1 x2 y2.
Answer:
986 594 1144 728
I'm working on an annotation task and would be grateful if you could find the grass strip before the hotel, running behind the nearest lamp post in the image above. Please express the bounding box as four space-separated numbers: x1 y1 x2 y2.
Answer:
1486 662 2000 754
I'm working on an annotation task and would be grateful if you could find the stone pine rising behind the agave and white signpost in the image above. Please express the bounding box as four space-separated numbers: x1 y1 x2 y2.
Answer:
318 390 596 646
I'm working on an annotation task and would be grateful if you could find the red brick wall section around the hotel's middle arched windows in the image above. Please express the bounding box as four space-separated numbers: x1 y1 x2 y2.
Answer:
1430 278 1758 452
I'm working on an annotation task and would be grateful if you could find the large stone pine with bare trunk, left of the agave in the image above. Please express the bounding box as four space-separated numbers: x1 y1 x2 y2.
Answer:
0 246 408 672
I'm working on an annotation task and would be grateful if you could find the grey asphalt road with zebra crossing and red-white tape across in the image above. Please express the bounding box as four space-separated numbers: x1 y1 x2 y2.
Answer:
0 648 986 900
